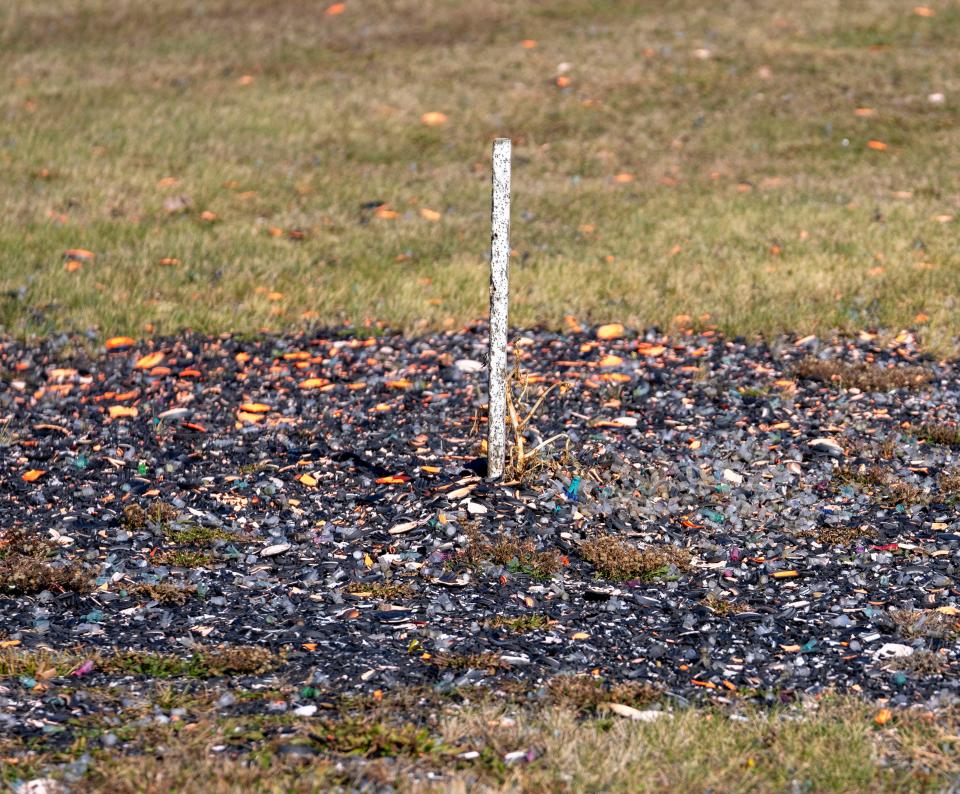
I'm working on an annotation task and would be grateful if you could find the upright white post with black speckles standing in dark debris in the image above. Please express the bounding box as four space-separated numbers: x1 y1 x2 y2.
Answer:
487 138 511 480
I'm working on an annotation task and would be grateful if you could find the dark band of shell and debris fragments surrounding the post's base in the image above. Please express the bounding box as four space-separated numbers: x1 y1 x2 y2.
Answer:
0 326 960 768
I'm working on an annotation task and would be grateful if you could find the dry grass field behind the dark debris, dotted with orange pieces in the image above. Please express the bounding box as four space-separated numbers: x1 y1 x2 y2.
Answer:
0 0 960 352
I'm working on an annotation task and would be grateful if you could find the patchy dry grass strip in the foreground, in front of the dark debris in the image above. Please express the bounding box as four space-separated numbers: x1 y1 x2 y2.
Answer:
0 651 960 794
